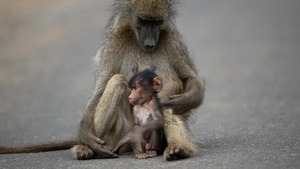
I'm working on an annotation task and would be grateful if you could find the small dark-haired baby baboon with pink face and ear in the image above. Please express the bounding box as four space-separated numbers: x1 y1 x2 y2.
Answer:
112 69 164 159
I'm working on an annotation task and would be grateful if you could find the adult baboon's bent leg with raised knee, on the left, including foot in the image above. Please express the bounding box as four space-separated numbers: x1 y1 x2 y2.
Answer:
72 74 133 160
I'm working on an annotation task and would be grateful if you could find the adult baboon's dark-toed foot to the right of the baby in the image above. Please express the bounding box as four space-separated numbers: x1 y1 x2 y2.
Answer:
164 143 191 161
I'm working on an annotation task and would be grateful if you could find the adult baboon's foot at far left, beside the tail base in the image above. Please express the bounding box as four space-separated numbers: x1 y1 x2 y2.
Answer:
71 145 95 160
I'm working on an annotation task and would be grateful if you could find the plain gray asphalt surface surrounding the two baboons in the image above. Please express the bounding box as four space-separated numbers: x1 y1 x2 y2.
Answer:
0 0 300 169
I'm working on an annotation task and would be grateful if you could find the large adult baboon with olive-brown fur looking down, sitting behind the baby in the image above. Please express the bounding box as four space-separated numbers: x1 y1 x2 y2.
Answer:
72 0 204 160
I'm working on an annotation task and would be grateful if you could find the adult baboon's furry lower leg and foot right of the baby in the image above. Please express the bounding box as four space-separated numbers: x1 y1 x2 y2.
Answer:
164 109 197 160
